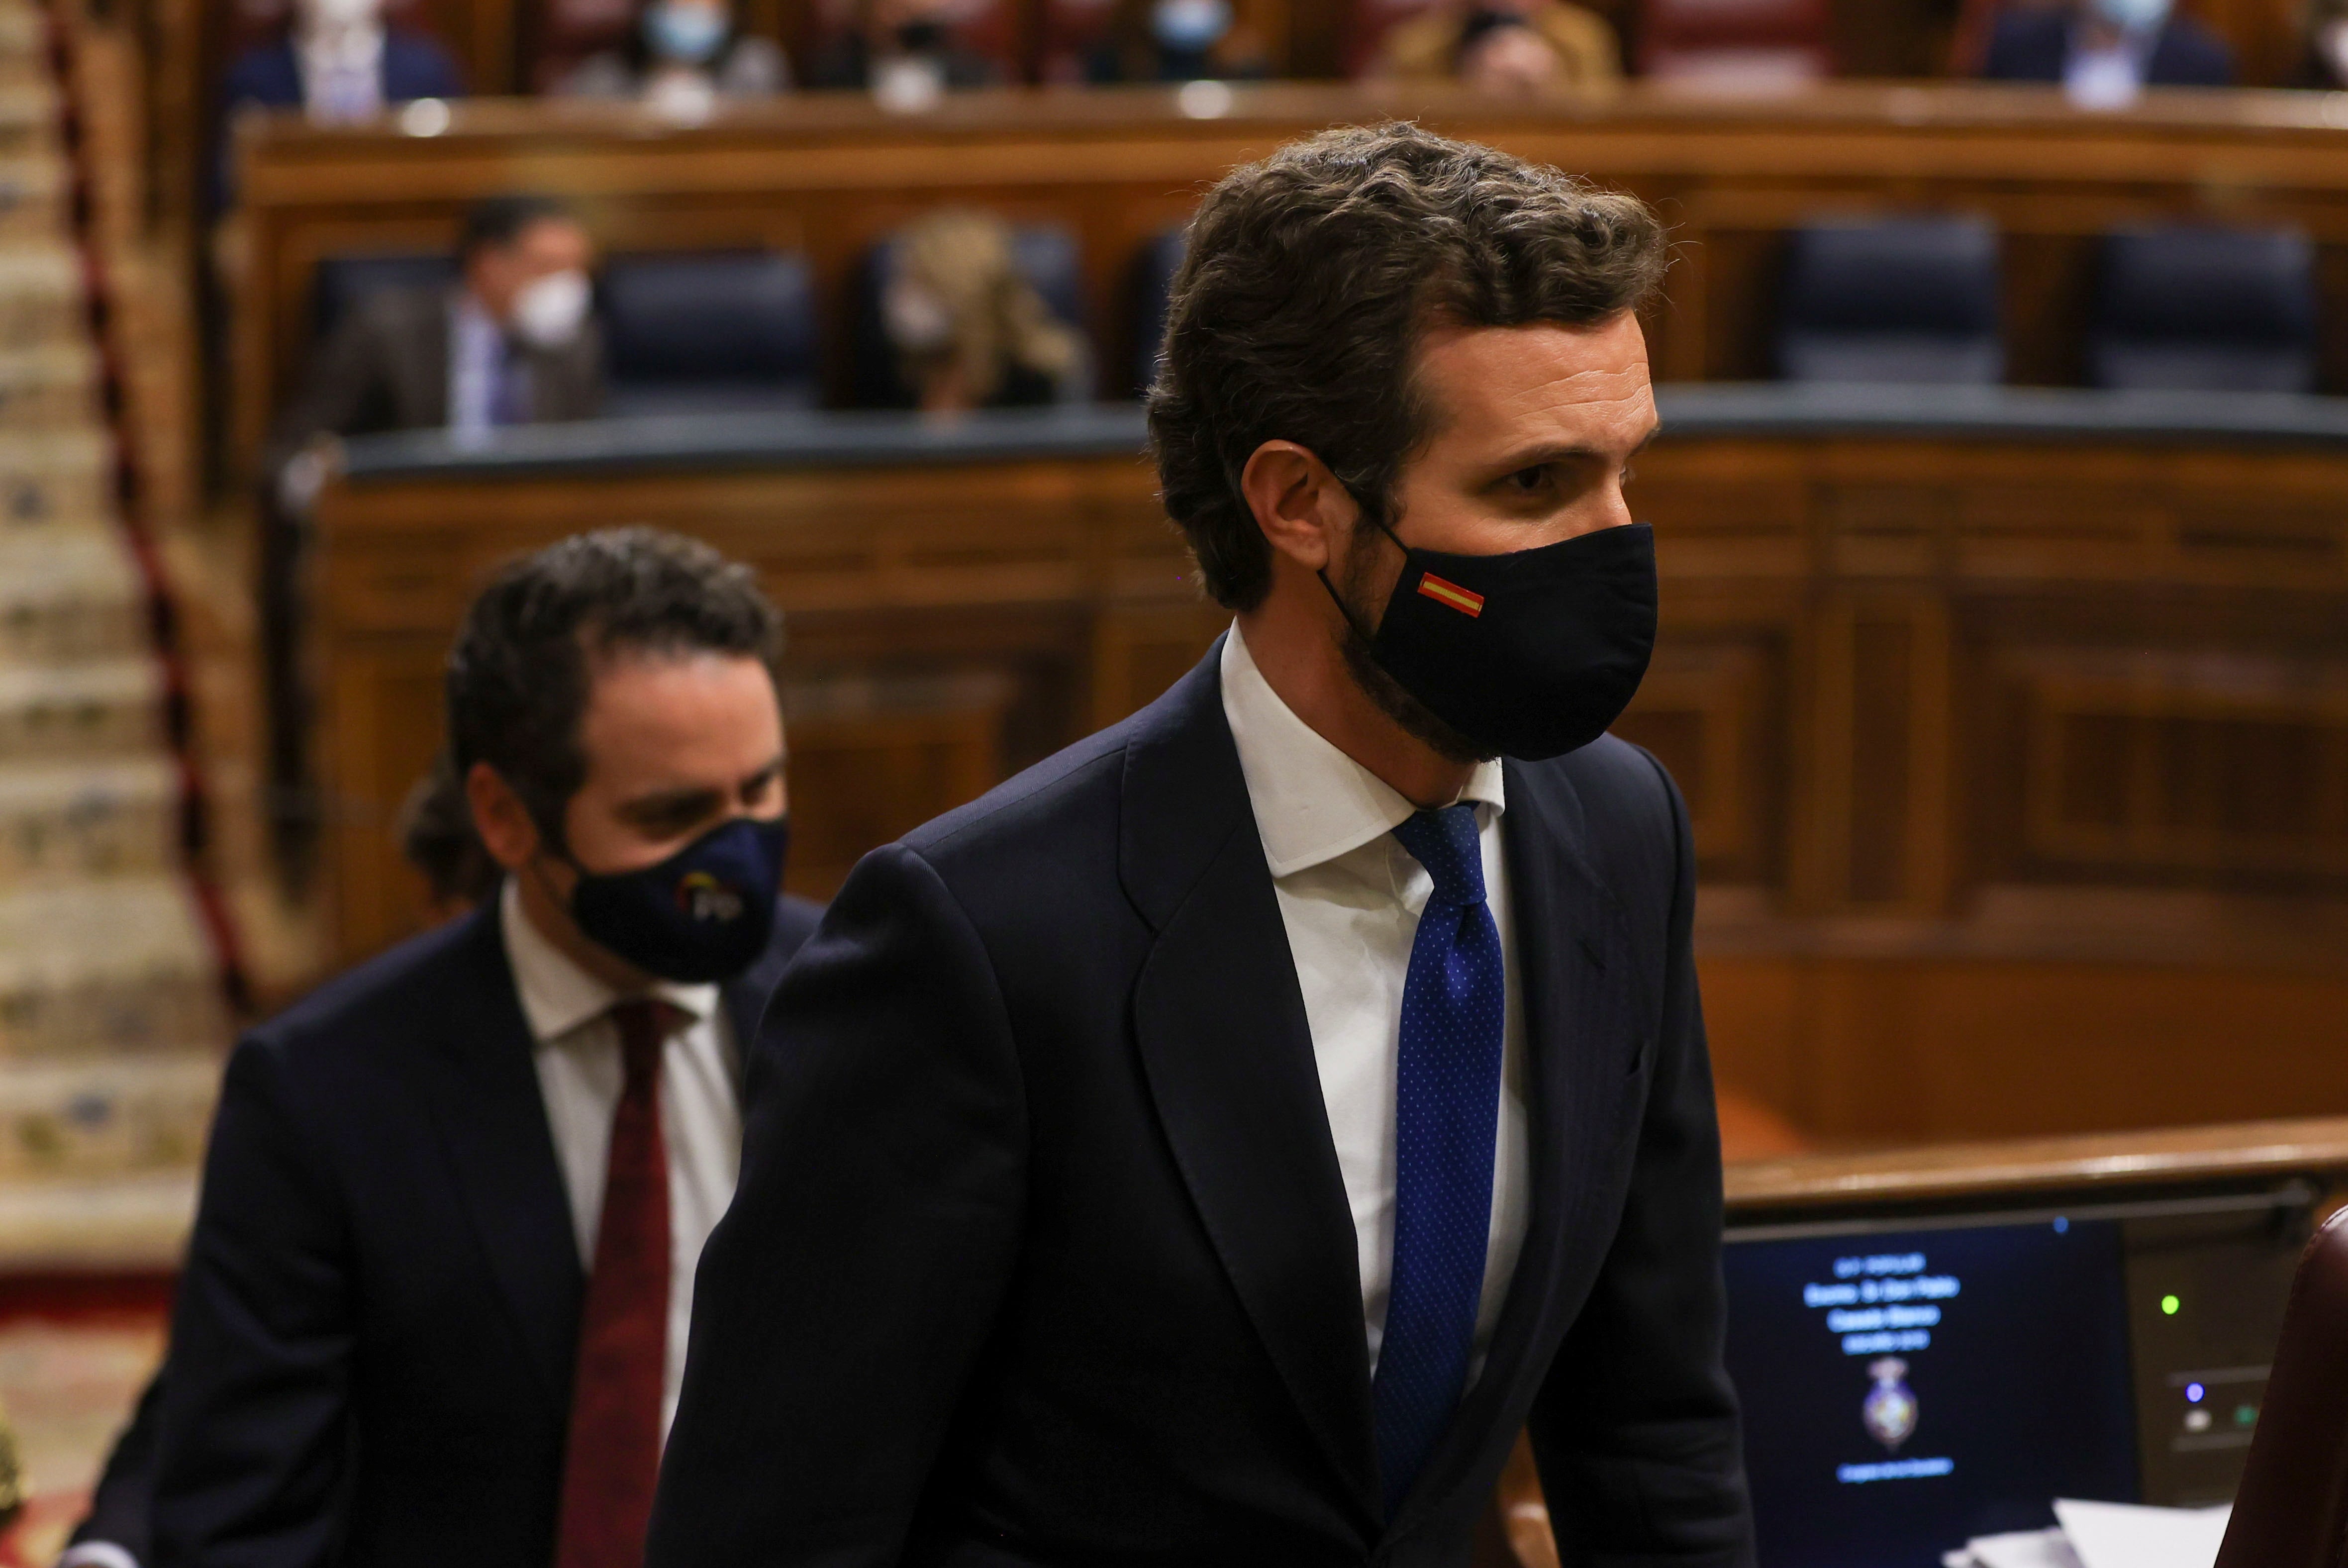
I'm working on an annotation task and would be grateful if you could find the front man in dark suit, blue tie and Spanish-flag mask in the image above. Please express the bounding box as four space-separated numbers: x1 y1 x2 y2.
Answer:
648 127 1752 1568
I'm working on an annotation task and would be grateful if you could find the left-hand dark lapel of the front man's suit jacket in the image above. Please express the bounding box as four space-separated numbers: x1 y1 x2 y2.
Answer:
1120 643 1378 1521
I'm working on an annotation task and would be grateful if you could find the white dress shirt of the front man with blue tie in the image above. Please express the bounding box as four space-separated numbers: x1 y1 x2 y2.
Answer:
1223 627 1531 1380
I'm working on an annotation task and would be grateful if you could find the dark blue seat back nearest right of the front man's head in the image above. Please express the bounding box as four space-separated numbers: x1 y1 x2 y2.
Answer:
1777 216 2005 385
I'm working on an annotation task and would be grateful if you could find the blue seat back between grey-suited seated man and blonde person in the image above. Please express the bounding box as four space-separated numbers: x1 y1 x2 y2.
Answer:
596 251 817 413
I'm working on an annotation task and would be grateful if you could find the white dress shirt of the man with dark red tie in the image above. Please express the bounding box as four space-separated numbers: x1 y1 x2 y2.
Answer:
498 878 742 1434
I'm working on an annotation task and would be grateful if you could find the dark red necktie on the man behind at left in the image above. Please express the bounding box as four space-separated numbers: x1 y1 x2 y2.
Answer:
554 1002 679 1568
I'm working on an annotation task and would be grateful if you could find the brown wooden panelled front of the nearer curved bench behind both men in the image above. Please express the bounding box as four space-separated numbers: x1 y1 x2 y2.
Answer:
314 420 2348 1143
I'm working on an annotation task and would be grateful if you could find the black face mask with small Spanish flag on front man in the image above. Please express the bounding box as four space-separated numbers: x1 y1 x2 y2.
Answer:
1322 523 1656 763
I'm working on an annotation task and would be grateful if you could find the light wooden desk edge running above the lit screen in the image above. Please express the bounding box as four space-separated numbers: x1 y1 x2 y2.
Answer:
1723 1117 2348 1218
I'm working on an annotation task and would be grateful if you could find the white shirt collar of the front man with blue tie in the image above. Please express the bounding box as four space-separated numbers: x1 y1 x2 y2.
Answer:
1221 622 1507 878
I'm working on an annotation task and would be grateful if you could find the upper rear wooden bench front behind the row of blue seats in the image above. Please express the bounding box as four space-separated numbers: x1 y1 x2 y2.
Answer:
232 85 2348 472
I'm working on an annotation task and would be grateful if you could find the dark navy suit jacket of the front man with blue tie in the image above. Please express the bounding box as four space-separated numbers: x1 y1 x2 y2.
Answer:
648 655 1752 1568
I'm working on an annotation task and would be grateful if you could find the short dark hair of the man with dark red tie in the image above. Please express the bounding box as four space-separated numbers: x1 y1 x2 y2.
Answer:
446 528 782 847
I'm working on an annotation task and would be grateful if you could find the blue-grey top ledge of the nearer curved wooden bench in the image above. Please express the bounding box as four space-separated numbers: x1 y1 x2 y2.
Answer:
345 383 2348 484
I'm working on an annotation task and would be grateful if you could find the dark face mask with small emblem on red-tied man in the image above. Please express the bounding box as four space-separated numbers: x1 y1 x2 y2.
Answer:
571 817 791 986
